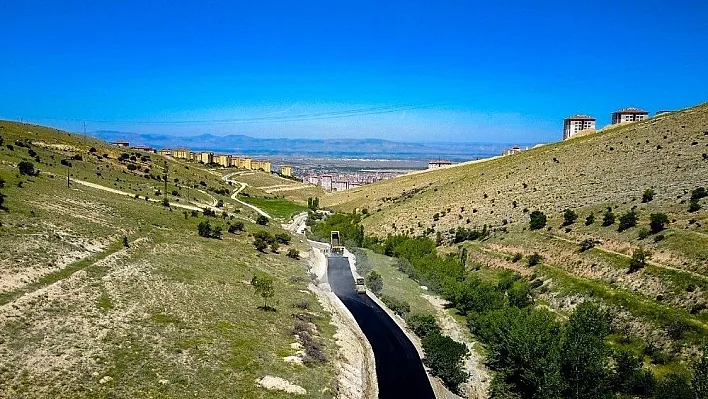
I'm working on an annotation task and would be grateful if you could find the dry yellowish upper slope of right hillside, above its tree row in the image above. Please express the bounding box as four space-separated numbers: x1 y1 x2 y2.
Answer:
323 105 708 239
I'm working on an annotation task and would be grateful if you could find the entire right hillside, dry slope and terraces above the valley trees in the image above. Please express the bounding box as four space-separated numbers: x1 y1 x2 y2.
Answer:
323 104 708 376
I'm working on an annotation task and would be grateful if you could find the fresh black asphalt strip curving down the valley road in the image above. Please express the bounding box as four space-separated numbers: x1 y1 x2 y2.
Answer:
327 257 435 399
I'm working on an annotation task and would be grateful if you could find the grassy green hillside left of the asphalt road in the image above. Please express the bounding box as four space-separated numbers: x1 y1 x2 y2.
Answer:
0 122 336 398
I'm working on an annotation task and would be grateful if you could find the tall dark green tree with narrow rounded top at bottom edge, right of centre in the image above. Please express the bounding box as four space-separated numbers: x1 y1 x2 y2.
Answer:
561 302 610 399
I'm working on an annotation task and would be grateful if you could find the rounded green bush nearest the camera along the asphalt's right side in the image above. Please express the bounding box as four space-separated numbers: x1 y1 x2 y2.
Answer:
422 334 469 392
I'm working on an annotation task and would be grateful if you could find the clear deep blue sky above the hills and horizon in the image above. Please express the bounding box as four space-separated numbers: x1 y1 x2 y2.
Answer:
0 0 708 143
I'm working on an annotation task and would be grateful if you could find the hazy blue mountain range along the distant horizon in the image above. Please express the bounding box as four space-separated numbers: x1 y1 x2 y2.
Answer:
89 130 511 161
